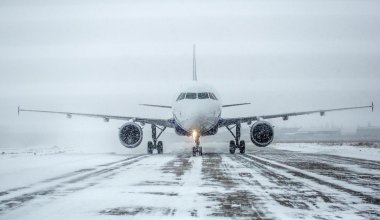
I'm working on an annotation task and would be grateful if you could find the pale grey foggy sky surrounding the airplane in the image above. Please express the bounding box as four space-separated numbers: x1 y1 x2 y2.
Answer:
0 0 380 152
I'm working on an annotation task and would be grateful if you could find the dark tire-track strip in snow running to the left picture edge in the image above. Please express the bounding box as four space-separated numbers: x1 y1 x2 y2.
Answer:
0 155 148 214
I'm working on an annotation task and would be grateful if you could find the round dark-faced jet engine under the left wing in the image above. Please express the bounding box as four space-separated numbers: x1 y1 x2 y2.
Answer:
119 122 143 148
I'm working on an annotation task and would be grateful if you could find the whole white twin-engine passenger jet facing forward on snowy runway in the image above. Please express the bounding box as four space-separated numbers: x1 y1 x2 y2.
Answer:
18 45 374 156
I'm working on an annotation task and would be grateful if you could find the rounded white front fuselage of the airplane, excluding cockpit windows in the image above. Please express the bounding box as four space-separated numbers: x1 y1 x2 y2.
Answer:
172 82 222 133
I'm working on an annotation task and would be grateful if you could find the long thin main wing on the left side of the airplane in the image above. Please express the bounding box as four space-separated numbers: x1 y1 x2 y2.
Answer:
18 107 174 128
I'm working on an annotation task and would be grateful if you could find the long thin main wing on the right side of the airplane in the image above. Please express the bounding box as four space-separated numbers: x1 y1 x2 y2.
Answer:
219 102 374 127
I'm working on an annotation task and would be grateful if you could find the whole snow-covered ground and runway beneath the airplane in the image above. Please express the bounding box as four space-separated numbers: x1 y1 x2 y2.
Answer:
0 143 380 220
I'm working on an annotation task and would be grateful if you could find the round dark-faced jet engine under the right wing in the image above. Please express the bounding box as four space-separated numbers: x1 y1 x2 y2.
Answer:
251 121 274 147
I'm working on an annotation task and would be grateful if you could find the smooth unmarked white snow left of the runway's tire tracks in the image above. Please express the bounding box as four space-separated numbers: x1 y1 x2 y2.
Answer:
0 147 131 191
